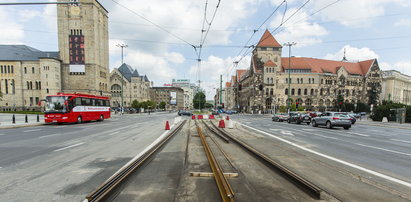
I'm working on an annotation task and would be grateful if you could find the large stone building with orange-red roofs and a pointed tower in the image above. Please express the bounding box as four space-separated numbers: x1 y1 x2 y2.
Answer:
236 31 382 113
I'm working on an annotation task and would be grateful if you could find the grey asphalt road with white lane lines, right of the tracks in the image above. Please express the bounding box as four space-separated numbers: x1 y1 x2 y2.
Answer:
231 115 411 193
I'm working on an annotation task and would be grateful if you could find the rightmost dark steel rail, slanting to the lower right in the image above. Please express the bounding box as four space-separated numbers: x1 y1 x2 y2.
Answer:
210 121 324 199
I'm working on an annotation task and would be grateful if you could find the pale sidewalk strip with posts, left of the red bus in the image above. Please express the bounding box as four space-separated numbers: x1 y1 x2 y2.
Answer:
0 114 44 129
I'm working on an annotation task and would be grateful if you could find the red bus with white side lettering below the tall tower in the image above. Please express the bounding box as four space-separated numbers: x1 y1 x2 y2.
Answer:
42 93 110 123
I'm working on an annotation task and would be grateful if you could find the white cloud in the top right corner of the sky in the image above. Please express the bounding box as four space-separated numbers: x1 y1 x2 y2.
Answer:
313 0 411 27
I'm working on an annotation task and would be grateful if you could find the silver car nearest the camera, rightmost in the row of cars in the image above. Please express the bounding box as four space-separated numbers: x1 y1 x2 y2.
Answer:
311 112 351 130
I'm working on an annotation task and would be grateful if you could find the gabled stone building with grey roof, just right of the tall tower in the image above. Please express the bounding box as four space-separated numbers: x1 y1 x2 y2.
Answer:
110 63 151 107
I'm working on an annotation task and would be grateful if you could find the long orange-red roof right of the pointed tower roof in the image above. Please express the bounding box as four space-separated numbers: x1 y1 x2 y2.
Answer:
281 57 375 76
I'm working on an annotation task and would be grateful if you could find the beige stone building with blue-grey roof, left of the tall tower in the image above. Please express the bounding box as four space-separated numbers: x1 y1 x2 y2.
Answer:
0 45 61 111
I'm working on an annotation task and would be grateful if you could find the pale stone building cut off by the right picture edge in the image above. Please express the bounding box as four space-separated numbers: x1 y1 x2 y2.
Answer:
380 70 411 105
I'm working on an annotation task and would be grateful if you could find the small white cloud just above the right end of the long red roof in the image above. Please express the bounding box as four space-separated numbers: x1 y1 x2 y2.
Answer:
324 45 379 61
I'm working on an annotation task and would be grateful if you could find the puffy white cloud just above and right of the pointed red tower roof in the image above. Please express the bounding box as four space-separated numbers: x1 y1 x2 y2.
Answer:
270 8 328 47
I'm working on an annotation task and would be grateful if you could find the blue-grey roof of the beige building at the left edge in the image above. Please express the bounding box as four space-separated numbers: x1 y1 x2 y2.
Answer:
0 45 60 61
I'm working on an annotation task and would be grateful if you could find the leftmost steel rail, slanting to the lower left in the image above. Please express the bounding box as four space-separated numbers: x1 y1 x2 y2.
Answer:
84 120 186 202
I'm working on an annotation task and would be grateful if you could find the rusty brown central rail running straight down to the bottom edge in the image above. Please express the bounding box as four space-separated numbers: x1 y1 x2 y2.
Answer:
196 124 234 202
